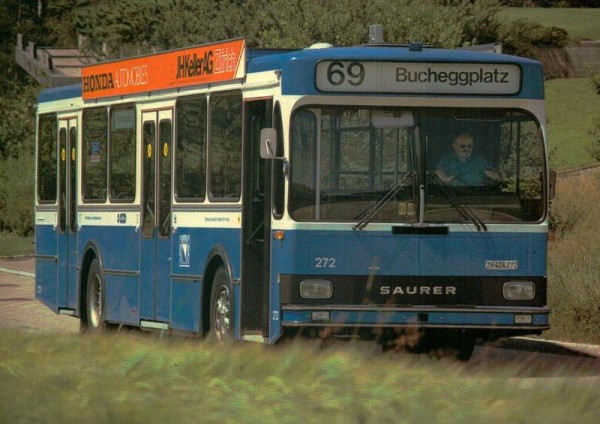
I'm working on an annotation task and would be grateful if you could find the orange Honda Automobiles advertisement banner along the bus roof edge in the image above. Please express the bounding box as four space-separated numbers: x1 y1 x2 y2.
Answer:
81 39 246 100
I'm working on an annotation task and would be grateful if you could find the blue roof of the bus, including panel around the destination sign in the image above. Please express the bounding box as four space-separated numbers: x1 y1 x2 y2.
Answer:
38 45 544 103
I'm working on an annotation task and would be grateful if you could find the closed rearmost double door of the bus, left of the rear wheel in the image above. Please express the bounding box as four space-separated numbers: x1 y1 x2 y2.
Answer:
57 118 77 309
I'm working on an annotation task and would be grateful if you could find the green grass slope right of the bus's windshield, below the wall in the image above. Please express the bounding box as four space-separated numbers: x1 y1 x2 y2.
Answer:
545 77 600 170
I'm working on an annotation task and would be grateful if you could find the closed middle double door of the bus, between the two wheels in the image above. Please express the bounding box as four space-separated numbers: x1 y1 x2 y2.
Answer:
140 109 173 322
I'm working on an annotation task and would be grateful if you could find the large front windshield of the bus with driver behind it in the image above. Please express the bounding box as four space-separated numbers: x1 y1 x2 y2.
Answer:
289 106 545 225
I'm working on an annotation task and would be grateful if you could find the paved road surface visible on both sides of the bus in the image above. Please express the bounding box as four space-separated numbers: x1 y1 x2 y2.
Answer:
0 258 600 376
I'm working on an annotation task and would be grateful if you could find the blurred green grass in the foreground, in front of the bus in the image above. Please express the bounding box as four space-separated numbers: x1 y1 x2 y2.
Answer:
0 333 600 423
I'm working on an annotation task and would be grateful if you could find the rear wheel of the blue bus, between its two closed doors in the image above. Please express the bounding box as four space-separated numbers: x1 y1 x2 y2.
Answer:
81 259 106 333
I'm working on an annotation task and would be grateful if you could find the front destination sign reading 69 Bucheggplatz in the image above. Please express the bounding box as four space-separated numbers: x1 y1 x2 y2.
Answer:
316 61 521 95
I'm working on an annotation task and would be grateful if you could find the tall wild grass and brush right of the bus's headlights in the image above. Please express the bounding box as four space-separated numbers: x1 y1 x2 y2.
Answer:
546 175 600 343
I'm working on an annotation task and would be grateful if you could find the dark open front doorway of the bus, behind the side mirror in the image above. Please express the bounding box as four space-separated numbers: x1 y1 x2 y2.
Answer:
242 100 273 338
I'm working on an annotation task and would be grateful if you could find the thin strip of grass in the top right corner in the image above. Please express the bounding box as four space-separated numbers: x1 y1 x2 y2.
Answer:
499 7 600 40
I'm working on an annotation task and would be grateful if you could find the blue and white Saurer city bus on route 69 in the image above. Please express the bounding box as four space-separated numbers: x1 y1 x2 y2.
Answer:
35 32 553 358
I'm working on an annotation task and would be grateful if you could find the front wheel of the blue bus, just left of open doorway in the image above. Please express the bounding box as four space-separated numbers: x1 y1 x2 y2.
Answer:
209 265 233 343
